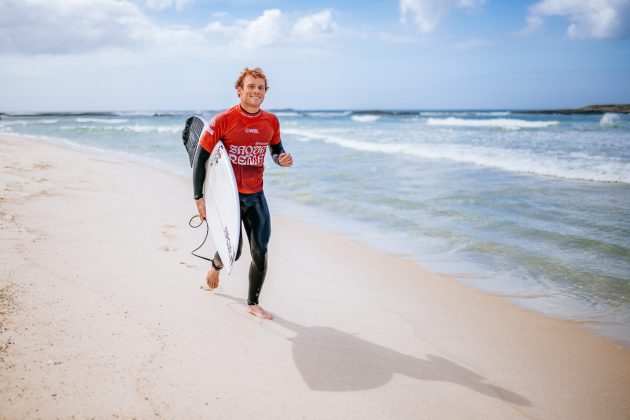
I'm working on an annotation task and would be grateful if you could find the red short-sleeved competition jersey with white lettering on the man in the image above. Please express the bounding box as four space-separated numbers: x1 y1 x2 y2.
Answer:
199 105 280 194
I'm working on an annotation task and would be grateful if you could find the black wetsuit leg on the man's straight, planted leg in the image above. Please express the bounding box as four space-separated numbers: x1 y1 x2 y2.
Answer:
241 191 271 305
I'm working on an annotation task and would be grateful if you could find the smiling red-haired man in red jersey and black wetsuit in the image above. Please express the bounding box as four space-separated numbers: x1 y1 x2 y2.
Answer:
193 67 293 319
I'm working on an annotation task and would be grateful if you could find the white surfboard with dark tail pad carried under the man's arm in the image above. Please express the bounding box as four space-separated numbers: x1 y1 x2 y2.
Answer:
182 116 241 274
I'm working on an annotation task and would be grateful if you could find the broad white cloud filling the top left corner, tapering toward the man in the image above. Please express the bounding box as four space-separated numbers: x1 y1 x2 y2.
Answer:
0 0 203 54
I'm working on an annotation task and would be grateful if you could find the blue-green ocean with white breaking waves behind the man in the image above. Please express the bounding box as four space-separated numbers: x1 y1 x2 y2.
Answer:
0 110 630 345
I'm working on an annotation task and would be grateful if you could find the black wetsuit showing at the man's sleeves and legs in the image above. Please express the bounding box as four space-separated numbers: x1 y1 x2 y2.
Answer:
193 142 284 305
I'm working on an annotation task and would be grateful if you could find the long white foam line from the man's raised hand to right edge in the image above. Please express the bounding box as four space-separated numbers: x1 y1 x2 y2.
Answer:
285 129 630 184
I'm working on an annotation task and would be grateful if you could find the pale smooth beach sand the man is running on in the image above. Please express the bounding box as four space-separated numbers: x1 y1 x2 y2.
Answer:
0 136 630 419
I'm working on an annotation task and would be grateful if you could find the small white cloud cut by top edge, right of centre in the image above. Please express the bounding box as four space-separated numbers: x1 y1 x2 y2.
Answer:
399 0 485 33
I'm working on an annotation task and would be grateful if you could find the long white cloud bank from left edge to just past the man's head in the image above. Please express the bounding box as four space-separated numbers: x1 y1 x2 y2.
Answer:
0 0 337 55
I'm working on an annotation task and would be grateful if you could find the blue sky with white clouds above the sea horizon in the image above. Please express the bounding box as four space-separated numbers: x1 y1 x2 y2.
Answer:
0 0 630 112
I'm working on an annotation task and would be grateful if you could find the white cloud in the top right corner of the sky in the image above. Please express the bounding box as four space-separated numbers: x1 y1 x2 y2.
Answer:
517 0 630 38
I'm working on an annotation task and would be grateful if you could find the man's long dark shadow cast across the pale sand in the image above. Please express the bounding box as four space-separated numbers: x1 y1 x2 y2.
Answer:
216 293 531 406
